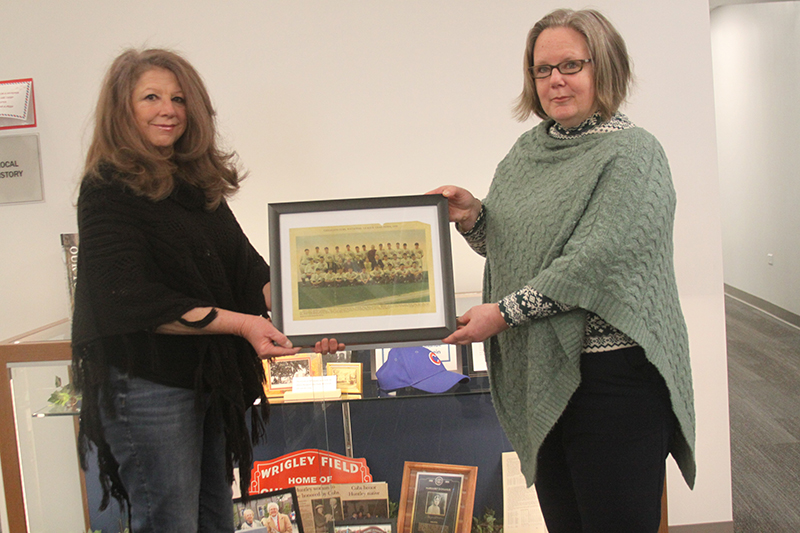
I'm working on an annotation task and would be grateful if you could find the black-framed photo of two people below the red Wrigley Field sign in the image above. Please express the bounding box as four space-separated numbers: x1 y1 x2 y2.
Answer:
233 487 304 533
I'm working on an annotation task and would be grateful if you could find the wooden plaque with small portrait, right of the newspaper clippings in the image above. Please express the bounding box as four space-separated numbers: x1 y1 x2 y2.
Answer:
397 461 478 533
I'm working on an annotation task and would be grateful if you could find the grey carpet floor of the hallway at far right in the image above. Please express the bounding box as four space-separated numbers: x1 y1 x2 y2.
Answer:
725 296 800 533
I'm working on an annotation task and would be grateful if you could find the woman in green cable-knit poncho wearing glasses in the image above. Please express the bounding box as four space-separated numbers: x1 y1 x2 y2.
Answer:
431 9 695 533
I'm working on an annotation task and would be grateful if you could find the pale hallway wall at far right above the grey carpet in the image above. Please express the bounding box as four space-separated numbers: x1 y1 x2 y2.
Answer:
711 2 800 314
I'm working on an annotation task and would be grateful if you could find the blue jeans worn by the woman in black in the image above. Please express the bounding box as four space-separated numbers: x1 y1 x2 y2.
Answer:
101 367 233 533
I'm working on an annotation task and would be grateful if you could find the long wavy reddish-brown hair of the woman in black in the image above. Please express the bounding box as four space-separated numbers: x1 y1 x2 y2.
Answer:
83 48 245 210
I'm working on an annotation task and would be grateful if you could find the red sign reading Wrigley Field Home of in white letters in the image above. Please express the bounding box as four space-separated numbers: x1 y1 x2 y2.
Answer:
250 449 372 494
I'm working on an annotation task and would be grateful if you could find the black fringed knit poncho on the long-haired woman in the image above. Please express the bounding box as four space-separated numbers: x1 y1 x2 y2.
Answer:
72 168 269 509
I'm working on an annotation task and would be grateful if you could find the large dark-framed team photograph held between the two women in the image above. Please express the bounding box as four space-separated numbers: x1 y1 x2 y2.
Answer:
268 195 456 346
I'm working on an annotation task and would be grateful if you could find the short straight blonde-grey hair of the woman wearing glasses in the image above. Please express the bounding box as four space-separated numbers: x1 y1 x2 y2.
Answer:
514 9 633 121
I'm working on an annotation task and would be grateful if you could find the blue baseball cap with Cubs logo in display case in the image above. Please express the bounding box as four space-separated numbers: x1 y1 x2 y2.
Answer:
375 346 469 392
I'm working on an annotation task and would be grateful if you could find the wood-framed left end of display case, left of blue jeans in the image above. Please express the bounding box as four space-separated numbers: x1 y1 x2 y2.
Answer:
0 319 89 533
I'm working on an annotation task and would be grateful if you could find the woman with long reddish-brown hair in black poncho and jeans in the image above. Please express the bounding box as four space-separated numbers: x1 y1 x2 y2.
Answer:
72 49 339 533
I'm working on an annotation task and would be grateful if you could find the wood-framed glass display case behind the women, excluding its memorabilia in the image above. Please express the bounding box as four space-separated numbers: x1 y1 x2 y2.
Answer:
0 297 505 533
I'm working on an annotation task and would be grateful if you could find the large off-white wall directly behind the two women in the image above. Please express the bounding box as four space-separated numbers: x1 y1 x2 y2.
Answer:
0 0 731 525
